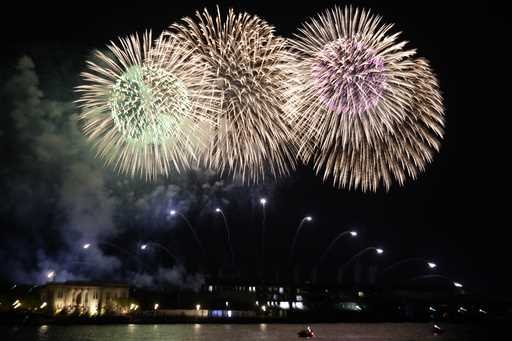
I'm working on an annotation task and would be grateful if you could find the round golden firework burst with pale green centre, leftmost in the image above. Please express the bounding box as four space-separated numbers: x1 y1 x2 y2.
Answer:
77 32 219 180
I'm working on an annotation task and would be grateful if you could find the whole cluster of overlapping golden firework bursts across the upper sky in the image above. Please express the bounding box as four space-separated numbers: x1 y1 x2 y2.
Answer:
78 7 444 191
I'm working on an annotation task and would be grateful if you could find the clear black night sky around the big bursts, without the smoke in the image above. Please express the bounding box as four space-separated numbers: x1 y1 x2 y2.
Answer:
0 1 504 295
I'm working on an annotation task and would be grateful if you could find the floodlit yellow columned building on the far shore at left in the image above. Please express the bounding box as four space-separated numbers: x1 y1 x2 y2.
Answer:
39 282 130 316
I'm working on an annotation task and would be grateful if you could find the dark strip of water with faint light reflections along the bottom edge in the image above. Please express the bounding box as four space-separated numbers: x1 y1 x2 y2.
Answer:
0 323 494 341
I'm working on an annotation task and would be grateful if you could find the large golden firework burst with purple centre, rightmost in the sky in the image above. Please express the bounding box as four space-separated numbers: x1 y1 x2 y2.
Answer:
286 7 444 191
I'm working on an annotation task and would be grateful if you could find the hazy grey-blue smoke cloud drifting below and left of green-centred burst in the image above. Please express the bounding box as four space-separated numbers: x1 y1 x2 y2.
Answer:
0 57 264 289
